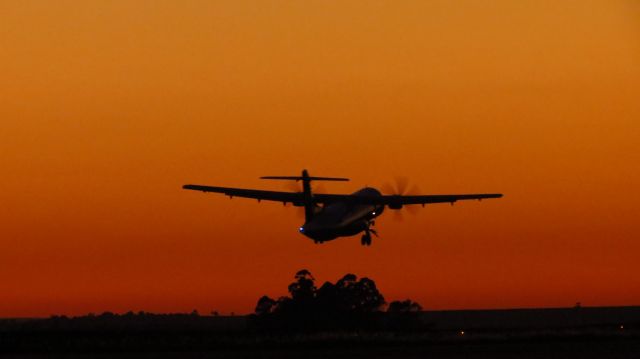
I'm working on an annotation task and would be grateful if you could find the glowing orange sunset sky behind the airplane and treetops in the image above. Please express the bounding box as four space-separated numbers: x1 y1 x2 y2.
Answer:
0 0 640 317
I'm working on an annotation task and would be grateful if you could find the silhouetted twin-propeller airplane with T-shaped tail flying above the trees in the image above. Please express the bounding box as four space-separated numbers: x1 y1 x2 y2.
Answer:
182 170 502 246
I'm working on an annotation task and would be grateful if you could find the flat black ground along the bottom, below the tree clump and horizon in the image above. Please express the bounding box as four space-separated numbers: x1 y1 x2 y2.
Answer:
0 307 640 359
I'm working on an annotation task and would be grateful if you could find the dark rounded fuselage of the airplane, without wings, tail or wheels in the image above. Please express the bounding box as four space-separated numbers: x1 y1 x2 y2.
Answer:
299 187 384 242
